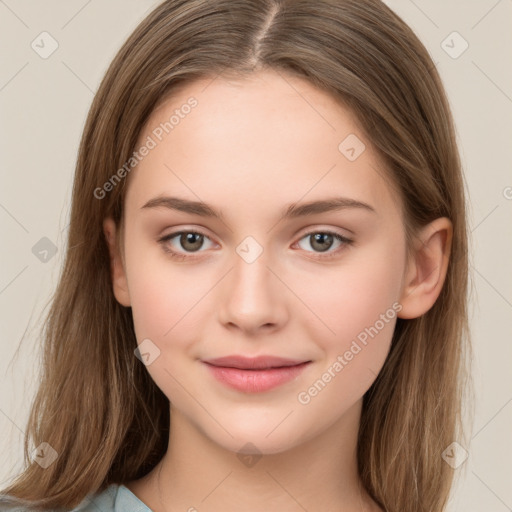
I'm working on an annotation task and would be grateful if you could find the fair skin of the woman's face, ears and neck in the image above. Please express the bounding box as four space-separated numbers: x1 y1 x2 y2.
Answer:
104 71 452 512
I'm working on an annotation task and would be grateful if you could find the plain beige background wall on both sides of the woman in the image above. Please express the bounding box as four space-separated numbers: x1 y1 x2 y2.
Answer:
0 0 512 512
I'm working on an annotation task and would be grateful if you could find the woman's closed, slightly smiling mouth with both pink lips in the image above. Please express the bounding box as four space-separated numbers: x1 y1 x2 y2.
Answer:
203 356 311 393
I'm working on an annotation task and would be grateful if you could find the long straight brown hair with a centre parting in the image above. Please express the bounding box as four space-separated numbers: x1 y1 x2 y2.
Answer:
4 0 471 512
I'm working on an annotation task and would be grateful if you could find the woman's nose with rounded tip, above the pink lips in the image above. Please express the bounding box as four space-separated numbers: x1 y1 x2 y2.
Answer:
217 245 289 335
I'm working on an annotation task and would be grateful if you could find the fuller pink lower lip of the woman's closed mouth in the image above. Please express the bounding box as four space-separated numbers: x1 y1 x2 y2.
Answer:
205 361 311 393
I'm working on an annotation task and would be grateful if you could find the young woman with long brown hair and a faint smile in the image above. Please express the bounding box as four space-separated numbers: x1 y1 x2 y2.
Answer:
2 0 469 512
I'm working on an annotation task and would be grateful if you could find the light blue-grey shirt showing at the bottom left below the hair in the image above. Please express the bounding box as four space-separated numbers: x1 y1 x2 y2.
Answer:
0 484 152 512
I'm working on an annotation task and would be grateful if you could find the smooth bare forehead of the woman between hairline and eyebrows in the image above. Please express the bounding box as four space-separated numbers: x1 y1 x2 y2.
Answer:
126 71 397 220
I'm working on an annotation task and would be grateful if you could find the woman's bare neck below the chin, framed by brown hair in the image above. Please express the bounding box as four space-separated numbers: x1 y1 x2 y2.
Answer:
129 401 379 512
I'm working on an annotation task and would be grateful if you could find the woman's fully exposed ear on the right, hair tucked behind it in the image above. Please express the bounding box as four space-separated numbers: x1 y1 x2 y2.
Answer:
398 217 453 318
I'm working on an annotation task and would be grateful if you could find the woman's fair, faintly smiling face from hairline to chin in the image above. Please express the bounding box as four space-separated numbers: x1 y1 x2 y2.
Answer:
108 72 412 453
